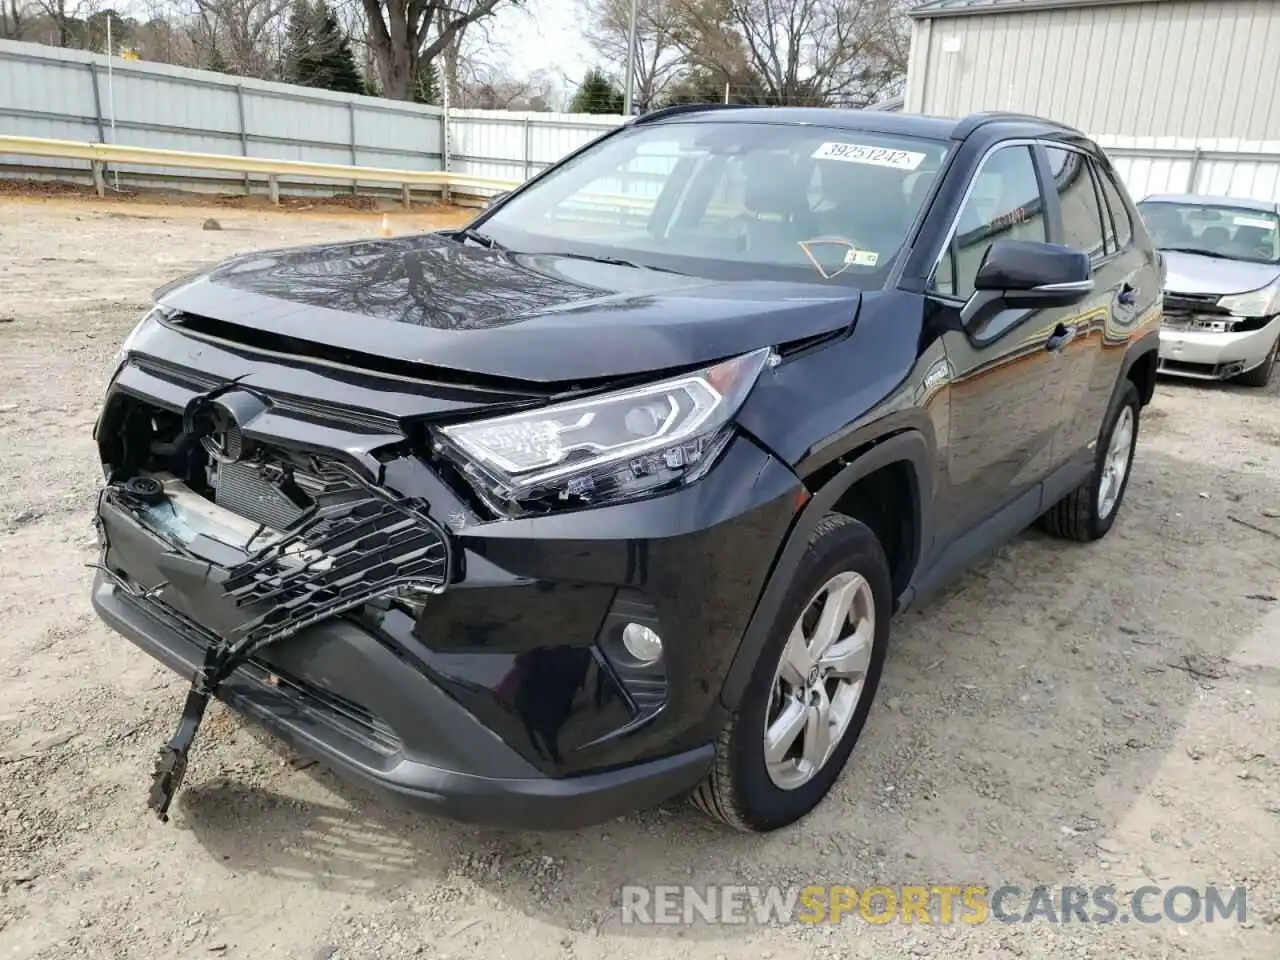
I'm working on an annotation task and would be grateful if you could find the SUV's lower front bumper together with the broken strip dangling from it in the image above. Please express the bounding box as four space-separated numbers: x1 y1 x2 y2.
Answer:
92 488 710 829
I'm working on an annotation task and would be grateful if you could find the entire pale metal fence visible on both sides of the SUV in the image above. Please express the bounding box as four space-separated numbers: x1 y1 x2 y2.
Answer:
0 41 1280 202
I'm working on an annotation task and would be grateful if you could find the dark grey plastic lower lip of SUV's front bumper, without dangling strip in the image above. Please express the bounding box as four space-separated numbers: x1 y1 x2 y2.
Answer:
92 573 713 829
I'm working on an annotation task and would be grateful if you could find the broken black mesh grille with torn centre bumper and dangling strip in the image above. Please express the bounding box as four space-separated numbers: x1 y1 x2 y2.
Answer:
96 463 452 819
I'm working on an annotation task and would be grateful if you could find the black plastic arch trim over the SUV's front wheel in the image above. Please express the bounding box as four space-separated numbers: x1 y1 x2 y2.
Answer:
721 429 933 709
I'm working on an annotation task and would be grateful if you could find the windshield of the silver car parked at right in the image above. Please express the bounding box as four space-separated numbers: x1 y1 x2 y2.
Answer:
1138 200 1280 264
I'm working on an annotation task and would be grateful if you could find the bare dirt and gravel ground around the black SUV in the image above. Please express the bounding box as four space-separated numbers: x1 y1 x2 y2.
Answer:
0 197 1280 960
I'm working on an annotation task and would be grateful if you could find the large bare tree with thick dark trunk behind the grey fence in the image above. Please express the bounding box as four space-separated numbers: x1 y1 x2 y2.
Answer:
361 0 520 100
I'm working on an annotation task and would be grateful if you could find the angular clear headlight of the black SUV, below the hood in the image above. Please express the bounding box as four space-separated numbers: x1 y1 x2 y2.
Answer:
433 349 771 515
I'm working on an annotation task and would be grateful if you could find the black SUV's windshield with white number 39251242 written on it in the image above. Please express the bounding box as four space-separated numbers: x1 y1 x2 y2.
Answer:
476 120 947 288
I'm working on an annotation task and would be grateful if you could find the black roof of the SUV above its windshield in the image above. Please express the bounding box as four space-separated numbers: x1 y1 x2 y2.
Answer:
634 104 1078 140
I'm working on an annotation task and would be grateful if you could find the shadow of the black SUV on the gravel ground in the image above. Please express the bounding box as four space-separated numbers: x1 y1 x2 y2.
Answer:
180 451 1280 937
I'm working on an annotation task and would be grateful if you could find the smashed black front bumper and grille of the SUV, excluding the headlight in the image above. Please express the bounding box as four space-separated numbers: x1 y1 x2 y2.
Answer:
93 313 797 827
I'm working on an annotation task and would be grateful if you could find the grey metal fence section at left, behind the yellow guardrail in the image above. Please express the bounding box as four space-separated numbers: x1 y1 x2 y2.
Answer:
0 41 443 189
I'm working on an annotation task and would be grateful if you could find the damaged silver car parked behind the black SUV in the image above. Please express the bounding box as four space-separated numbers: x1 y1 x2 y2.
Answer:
1138 196 1280 387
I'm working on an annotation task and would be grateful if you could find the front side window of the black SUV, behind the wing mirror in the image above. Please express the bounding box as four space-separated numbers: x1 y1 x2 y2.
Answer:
933 147 1047 300
